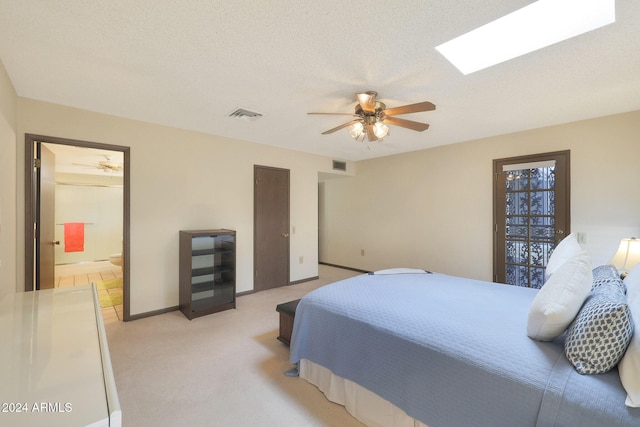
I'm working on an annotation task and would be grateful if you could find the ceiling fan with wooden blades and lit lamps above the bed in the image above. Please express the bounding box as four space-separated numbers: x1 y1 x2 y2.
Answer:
307 91 436 142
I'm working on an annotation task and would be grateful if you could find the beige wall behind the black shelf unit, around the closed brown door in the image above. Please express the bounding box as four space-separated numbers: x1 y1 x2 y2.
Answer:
15 98 356 315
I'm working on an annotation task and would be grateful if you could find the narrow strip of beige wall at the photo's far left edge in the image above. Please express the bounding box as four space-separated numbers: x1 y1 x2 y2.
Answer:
0 61 18 299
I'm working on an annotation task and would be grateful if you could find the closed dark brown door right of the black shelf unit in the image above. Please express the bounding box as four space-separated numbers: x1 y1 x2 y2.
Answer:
253 165 289 291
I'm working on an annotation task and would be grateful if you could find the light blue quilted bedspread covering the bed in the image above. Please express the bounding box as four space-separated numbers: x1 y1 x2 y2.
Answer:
290 274 640 427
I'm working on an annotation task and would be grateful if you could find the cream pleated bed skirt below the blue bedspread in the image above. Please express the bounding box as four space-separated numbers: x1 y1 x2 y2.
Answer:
299 359 427 427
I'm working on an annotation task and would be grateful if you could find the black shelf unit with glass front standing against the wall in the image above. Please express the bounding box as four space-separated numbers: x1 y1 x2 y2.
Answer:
179 229 236 320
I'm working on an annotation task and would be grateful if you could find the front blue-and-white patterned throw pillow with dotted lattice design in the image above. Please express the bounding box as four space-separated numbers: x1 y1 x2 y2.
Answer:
564 285 633 374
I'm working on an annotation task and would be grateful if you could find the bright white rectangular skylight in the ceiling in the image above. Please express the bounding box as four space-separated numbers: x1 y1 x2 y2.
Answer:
436 0 616 74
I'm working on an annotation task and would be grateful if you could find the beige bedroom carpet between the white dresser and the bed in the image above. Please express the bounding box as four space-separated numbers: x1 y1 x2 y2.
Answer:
106 265 362 427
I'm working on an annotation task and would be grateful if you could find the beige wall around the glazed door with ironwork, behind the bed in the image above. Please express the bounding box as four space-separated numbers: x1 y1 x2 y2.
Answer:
320 111 640 280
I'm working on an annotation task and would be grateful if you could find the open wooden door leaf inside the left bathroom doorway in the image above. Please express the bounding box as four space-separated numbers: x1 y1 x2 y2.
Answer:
36 142 60 289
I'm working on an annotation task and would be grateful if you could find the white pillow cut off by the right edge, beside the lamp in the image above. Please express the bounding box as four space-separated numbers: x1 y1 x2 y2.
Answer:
618 264 640 408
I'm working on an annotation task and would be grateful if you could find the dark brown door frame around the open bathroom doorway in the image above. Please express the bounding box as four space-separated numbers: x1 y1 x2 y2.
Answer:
24 133 131 321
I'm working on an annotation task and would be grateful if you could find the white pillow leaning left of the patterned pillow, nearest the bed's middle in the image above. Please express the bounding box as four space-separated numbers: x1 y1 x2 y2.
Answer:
527 252 593 341
